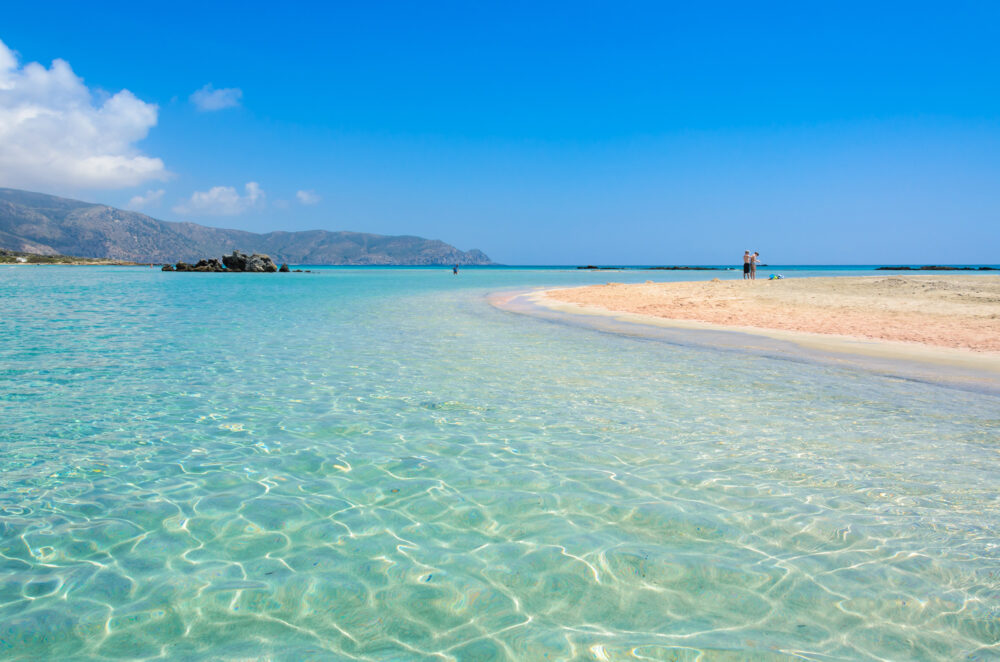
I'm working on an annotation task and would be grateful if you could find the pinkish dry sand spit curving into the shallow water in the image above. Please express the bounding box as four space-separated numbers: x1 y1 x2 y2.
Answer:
546 275 1000 355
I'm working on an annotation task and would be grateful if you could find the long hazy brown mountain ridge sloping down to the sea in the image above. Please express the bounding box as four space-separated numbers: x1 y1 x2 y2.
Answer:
0 188 492 265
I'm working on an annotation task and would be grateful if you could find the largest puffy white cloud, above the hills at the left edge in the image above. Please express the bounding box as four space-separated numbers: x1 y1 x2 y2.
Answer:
0 41 167 190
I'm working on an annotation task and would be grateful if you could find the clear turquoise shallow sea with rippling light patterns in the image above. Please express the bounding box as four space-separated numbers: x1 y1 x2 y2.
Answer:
0 267 1000 660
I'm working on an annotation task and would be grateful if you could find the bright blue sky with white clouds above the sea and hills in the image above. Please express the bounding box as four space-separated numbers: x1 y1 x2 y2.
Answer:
0 1 1000 264
